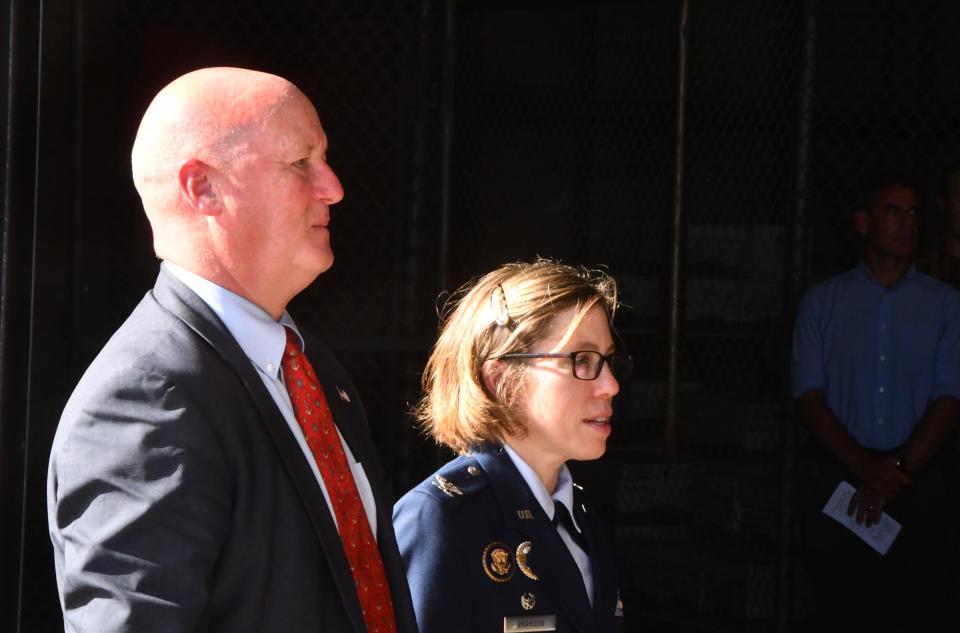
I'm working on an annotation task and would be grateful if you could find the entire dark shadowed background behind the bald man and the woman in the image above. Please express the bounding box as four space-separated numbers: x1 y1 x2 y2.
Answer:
0 0 960 633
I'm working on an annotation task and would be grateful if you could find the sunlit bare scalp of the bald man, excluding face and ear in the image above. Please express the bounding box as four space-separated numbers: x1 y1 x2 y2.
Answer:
131 67 301 257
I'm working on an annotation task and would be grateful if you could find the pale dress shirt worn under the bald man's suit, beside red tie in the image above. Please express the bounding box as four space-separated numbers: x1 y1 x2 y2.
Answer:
161 261 377 538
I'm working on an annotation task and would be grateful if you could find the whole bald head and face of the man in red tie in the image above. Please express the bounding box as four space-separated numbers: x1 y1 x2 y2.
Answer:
132 68 343 318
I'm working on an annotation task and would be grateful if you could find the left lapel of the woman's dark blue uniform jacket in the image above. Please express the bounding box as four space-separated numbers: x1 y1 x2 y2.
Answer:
476 450 596 633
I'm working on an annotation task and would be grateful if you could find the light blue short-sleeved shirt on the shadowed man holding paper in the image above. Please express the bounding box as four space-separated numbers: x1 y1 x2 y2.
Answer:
791 262 960 450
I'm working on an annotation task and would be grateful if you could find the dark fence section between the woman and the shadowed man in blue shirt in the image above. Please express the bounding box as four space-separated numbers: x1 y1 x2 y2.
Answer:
453 1 800 630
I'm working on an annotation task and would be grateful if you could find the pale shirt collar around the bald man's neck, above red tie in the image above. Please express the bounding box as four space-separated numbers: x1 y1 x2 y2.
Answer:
161 261 304 380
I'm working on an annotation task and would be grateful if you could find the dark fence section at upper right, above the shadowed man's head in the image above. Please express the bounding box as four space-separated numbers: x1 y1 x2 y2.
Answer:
802 1 960 281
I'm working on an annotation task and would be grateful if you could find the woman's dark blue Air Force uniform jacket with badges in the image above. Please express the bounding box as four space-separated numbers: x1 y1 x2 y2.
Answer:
393 447 623 633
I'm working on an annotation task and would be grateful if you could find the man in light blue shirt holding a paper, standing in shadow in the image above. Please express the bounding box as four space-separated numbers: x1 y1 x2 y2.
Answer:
792 173 960 630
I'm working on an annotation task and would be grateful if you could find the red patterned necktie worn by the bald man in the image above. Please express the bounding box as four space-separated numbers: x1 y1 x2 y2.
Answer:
280 327 396 633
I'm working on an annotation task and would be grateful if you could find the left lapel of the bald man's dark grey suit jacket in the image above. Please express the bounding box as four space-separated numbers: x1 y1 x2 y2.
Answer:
153 269 366 633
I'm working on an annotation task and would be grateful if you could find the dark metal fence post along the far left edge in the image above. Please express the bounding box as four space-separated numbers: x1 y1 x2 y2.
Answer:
0 0 43 631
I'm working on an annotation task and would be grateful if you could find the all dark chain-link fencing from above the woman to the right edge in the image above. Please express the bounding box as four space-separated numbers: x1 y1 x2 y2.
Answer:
452 0 960 630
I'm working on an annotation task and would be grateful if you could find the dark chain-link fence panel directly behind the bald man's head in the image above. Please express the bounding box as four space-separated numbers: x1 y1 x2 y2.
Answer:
69 0 442 486
